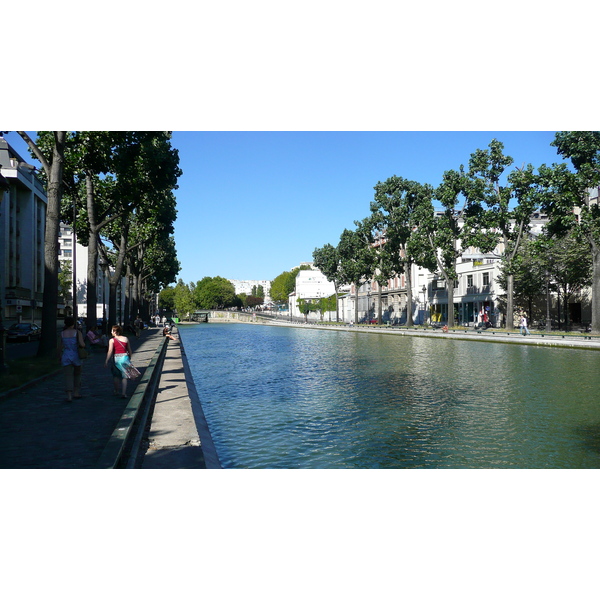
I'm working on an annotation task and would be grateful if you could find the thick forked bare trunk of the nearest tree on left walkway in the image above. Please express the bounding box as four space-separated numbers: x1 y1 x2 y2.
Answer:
17 131 67 356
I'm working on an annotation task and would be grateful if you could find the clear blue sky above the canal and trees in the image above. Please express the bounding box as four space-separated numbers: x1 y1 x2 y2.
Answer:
6 131 561 283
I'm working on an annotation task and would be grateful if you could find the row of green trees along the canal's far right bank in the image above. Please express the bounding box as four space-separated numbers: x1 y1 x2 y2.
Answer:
313 131 600 334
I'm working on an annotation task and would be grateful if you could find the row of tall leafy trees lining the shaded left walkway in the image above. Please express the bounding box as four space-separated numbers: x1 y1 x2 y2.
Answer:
18 131 182 355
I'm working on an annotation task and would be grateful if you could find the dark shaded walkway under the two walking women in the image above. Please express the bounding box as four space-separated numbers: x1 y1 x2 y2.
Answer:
0 329 163 469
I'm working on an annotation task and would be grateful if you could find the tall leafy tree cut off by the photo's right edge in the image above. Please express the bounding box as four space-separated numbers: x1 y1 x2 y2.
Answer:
540 131 600 334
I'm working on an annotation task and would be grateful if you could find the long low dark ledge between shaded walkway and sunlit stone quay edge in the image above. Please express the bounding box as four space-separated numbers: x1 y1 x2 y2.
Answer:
96 337 169 469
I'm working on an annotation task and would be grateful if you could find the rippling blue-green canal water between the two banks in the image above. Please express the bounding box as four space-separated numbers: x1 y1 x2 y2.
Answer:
179 323 600 469
